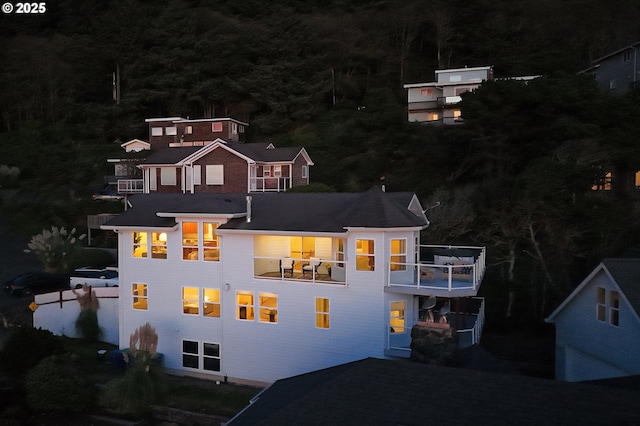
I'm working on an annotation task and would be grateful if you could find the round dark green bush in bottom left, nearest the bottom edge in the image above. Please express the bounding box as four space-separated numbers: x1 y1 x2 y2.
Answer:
24 355 97 414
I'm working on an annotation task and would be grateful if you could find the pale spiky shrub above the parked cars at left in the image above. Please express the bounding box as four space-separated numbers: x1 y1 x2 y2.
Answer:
25 226 86 272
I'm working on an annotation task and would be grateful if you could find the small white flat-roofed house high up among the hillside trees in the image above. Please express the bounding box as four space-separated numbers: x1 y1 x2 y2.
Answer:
404 66 535 125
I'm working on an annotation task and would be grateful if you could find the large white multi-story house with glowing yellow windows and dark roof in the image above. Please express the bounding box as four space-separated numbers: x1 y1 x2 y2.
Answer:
102 189 485 383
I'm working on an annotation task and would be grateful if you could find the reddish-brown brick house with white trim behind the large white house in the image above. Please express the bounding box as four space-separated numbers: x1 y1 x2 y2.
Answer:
96 117 313 198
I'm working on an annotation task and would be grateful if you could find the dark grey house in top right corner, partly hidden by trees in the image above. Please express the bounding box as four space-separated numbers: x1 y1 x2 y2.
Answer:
582 41 640 94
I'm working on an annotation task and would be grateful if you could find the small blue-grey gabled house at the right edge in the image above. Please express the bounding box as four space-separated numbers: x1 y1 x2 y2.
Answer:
546 258 640 382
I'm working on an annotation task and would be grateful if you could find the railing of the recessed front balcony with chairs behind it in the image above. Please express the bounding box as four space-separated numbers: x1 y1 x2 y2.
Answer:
253 256 347 285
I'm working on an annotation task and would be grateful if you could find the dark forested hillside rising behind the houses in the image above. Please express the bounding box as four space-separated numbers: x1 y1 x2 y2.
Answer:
0 0 640 320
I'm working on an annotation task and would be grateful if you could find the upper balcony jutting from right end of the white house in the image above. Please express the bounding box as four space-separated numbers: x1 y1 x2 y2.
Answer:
385 246 486 297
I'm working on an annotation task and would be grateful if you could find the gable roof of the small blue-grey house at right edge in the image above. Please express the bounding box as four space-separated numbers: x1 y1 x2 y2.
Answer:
545 258 640 322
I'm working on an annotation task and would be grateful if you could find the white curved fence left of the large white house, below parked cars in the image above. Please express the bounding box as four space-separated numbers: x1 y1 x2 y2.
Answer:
33 287 119 345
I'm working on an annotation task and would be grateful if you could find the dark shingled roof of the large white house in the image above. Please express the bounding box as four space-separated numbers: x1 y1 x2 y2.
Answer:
106 190 427 232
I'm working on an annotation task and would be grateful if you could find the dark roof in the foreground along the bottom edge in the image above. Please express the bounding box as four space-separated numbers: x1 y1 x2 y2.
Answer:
229 358 640 426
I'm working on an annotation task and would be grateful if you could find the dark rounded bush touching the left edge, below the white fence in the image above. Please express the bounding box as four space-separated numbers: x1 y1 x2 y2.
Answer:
0 327 64 376
